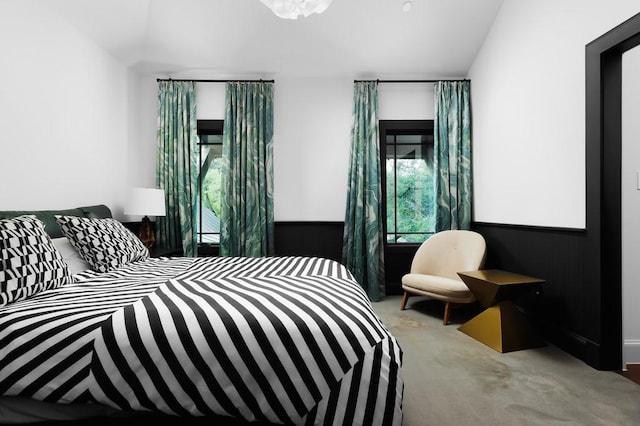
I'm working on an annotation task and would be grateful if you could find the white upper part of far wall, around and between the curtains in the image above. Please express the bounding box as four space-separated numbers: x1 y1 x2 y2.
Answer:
137 76 433 221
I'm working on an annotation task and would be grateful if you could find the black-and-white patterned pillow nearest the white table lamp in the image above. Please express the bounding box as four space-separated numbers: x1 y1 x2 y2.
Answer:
56 216 149 272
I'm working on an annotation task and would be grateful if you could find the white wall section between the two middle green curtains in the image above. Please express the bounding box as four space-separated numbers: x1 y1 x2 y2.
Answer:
273 78 353 221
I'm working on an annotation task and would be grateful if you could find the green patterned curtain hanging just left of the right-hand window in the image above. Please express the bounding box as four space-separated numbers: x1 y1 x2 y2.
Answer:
342 81 385 301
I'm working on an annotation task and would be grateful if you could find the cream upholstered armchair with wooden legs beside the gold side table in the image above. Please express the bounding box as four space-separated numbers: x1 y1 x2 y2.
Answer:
400 230 486 325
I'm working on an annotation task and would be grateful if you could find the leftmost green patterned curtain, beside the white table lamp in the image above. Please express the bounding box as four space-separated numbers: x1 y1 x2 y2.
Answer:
156 81 198 257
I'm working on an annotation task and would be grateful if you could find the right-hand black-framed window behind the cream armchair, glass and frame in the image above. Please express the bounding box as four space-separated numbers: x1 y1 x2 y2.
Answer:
380 120 435 245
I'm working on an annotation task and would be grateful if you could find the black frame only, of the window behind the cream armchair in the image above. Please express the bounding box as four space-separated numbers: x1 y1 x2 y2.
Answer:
378 120 434 247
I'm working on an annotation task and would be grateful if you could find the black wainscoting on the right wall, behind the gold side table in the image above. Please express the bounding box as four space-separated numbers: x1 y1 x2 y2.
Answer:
472 222 601 368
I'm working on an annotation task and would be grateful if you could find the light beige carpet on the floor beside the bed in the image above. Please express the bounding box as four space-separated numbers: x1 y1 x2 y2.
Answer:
373 296 640 426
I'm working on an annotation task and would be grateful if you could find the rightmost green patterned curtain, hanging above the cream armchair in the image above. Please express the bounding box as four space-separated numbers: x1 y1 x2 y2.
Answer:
433 81 471 231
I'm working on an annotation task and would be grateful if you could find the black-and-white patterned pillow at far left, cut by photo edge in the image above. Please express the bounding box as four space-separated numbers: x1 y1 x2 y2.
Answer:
0 215 72 306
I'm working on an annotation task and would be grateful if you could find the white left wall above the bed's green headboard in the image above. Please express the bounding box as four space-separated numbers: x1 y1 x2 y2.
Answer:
0 0 130 220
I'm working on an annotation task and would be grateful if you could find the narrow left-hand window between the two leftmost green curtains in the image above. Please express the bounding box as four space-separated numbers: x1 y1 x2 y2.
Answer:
196 120 224 245
